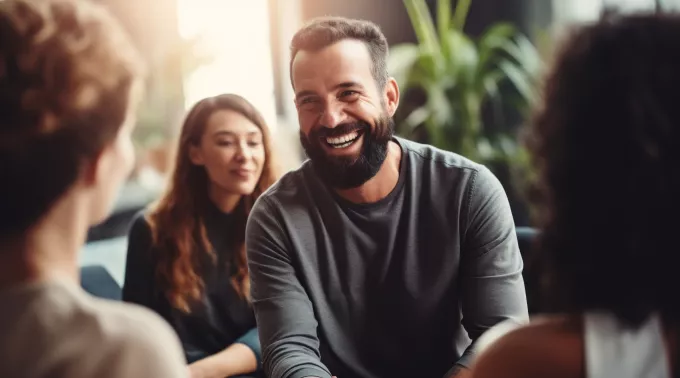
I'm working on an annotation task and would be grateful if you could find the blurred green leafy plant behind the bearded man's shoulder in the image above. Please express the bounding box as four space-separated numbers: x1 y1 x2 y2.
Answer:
388 0 543 224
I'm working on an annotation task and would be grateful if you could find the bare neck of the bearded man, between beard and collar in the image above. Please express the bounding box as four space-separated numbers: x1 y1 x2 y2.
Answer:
336 141 402 203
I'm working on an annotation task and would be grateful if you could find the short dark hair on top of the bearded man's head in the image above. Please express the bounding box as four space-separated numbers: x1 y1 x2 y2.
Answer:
290 17 388 89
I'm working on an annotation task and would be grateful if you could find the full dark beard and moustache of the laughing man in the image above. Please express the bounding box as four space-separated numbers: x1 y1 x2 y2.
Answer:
300 115 394 189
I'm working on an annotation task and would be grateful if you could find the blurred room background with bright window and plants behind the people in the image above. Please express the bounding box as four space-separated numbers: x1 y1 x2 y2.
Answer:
82 0 680 290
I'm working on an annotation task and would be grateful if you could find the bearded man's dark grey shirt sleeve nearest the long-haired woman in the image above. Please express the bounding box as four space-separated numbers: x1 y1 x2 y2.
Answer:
246 196 331 378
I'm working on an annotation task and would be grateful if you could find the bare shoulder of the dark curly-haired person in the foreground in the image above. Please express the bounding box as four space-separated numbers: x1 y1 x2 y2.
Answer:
472 316 584 378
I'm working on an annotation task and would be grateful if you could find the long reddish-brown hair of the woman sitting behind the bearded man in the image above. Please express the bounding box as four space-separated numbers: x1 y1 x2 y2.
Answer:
147 94 277 312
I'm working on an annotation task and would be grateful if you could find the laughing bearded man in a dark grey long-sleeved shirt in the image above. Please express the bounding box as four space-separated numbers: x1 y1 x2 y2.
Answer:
246 17 528 378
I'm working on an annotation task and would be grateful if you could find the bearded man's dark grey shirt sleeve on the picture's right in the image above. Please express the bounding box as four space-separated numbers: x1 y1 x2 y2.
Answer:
458 167 529 367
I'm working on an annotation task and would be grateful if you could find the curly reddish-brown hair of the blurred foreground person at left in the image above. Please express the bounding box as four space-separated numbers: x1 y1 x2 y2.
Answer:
0 0 143 235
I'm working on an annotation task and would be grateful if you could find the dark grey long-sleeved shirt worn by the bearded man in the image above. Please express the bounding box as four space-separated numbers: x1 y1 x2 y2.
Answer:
246 138 528 378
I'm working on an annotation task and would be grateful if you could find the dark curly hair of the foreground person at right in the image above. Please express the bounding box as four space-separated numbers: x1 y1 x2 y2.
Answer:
529 14 680 327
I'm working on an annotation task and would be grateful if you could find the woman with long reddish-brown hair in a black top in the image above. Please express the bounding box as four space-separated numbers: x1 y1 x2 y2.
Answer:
123 94 276 377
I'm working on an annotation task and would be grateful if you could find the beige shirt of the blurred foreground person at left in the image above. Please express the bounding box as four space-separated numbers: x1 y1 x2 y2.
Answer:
0 280 188 378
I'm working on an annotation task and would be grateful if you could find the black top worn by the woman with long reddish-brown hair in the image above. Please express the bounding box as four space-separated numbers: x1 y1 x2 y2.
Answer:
123 202 260 363
